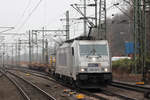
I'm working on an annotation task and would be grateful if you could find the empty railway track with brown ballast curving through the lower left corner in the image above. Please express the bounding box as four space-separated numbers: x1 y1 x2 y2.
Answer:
0 68 56 100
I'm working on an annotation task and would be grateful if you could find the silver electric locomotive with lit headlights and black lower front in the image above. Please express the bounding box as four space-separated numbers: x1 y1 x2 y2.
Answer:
55 40 112 88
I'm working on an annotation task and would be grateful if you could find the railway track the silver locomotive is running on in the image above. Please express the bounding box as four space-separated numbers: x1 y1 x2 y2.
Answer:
7 66 142 100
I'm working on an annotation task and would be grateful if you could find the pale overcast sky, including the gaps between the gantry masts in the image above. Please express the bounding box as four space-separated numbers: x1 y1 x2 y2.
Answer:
0 0 129 55
